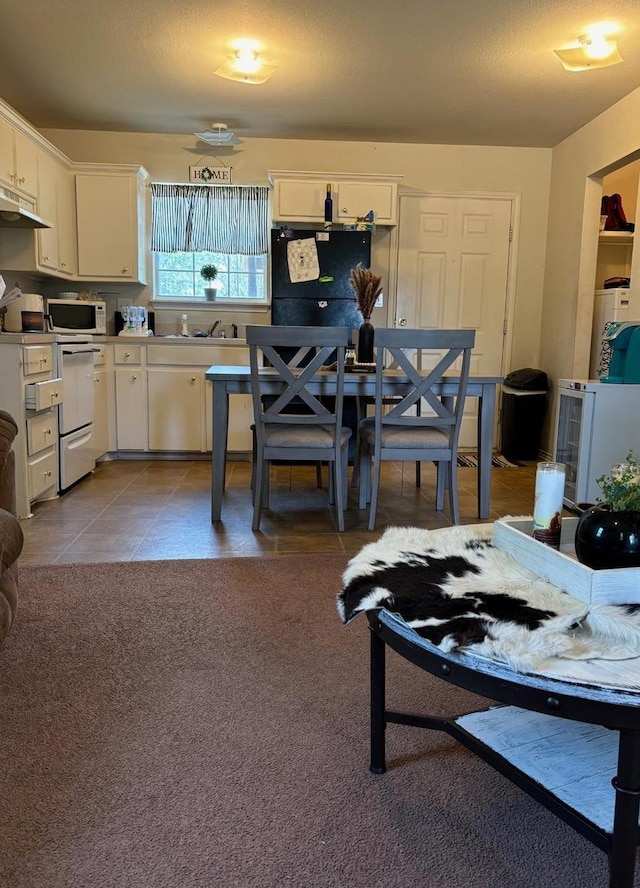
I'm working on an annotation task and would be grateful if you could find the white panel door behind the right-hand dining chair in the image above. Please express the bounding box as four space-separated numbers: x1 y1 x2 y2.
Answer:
395 195 512 448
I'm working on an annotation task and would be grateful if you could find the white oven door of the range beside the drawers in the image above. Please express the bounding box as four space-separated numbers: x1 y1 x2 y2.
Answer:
58 343 95 435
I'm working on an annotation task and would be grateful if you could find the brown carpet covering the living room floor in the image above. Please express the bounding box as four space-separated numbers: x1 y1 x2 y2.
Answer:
0 555 624 888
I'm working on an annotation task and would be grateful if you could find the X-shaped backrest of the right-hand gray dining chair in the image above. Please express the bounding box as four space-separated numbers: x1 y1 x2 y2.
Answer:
375 327 476 447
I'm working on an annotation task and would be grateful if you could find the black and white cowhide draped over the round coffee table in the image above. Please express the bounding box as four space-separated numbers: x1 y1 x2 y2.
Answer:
337 524 640 672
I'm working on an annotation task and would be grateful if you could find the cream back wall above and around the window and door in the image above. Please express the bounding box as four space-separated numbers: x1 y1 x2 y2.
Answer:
42 130 551 370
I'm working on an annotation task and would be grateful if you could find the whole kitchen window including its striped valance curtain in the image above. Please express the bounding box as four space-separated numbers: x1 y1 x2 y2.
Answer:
151 184 269 303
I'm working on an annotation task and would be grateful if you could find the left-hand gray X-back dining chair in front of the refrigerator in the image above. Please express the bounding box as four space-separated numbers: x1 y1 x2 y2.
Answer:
246 325 351 532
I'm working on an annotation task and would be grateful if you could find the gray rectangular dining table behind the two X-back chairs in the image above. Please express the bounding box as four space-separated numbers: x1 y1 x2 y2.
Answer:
205 365 502 523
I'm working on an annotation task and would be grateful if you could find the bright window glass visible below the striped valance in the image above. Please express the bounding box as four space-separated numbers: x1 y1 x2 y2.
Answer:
154 252 267 303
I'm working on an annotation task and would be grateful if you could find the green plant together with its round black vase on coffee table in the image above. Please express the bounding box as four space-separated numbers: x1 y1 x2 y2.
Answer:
576 451 640 570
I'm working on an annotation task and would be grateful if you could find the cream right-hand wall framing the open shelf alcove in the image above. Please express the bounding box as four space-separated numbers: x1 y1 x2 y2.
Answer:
540 89 640 449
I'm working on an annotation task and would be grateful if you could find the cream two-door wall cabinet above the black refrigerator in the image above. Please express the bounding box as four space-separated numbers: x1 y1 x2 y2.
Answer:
269 170 402 226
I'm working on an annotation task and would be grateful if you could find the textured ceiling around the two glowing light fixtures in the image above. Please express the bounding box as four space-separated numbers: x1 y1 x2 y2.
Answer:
0 0 640 147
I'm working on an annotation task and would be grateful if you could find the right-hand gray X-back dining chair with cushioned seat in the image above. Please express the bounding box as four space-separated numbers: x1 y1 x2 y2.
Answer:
358 328 475 530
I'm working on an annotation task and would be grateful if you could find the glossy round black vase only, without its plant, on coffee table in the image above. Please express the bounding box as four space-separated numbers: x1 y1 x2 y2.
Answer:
575 506 640 570
